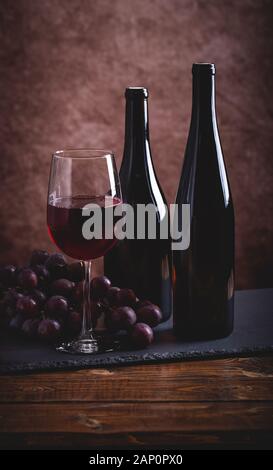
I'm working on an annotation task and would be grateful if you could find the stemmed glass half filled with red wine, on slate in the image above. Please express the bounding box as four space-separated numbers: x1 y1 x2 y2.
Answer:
47 149 122 354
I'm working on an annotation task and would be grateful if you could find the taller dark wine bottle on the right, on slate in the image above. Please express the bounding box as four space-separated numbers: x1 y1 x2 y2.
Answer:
173 63 234 340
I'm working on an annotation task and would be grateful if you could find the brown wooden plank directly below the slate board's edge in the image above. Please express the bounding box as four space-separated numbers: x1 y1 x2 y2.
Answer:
0 357 273 403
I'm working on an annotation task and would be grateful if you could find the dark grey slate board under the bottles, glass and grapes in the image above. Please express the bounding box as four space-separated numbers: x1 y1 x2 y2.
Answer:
0 289 273 373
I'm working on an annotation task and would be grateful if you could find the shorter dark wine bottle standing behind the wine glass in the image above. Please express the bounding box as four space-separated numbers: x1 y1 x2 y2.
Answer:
104 87 172 320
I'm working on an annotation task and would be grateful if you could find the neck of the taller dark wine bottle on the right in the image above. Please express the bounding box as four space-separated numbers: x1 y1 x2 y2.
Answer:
192 73 216 129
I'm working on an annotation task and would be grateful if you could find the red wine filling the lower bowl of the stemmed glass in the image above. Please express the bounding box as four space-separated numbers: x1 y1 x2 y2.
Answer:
47 195 121 260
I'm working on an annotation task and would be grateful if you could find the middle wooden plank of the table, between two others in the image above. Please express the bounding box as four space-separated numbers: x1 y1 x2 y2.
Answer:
0 402 273 435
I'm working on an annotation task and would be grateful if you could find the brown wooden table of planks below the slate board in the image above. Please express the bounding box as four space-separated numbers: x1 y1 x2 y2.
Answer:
0 356 273 449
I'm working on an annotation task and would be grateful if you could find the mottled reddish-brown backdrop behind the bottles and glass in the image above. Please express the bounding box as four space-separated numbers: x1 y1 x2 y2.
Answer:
0 0 273 288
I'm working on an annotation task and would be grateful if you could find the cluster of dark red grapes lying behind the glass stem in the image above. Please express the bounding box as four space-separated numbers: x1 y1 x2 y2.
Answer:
0 250 162 348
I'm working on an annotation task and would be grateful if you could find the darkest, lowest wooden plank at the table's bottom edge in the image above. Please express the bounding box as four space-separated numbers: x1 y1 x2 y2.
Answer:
0 430 273 453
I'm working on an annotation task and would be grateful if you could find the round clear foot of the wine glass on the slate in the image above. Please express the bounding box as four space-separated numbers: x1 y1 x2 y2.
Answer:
56 333 120 354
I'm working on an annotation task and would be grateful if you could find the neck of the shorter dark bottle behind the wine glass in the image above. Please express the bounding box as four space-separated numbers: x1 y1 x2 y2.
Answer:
124 97 149 164
